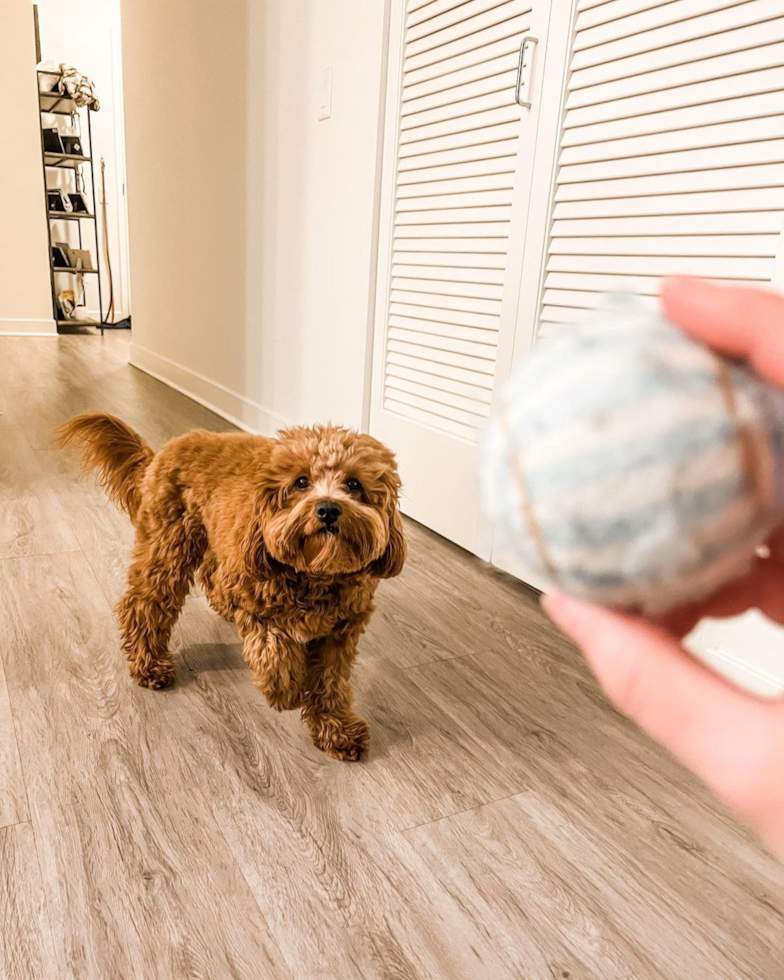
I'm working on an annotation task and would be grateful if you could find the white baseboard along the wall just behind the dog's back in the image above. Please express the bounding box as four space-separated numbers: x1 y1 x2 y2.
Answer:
130 343 293 435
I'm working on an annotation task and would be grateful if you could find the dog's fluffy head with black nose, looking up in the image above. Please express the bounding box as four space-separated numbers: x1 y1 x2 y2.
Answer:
245 425 406 578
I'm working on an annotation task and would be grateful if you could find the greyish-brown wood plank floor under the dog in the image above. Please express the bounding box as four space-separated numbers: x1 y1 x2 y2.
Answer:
0 335 784 980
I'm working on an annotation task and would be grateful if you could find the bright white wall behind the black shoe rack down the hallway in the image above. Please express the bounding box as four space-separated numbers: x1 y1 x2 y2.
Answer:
36 0 130 320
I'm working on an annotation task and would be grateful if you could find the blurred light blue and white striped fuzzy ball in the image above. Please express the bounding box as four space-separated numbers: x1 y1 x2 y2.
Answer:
483 294 784 613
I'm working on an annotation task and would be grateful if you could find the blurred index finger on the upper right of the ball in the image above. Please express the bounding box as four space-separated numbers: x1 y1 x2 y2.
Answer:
661 278 784 387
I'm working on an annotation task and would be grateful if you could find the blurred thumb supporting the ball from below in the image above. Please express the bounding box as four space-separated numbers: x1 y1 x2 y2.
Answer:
542 593 781 817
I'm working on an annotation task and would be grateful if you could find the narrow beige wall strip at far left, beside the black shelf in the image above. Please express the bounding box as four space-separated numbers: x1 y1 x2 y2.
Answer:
0 0 55 333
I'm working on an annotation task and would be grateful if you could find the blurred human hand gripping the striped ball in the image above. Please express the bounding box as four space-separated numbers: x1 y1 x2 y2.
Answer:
542 279 784 860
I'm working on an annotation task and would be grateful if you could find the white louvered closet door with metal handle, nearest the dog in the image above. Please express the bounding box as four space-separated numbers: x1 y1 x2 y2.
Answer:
370 0 569 553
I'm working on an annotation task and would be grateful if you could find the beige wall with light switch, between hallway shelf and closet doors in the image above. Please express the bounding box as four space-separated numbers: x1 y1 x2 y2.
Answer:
123 0 384 431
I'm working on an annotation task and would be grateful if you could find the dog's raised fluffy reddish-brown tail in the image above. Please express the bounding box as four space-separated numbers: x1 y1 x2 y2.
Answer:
55 412 154 520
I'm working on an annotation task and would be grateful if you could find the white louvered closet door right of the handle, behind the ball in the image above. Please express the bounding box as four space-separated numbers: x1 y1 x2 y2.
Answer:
493 0 784 584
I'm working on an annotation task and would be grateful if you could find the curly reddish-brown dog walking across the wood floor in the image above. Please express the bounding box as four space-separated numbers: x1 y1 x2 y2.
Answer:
57 412 406 761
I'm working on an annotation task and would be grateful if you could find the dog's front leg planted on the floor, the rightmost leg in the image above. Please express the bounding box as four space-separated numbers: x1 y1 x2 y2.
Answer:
302 623 370 762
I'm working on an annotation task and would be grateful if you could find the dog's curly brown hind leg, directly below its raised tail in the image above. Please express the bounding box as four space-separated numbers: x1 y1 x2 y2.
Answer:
117 515 206 688
